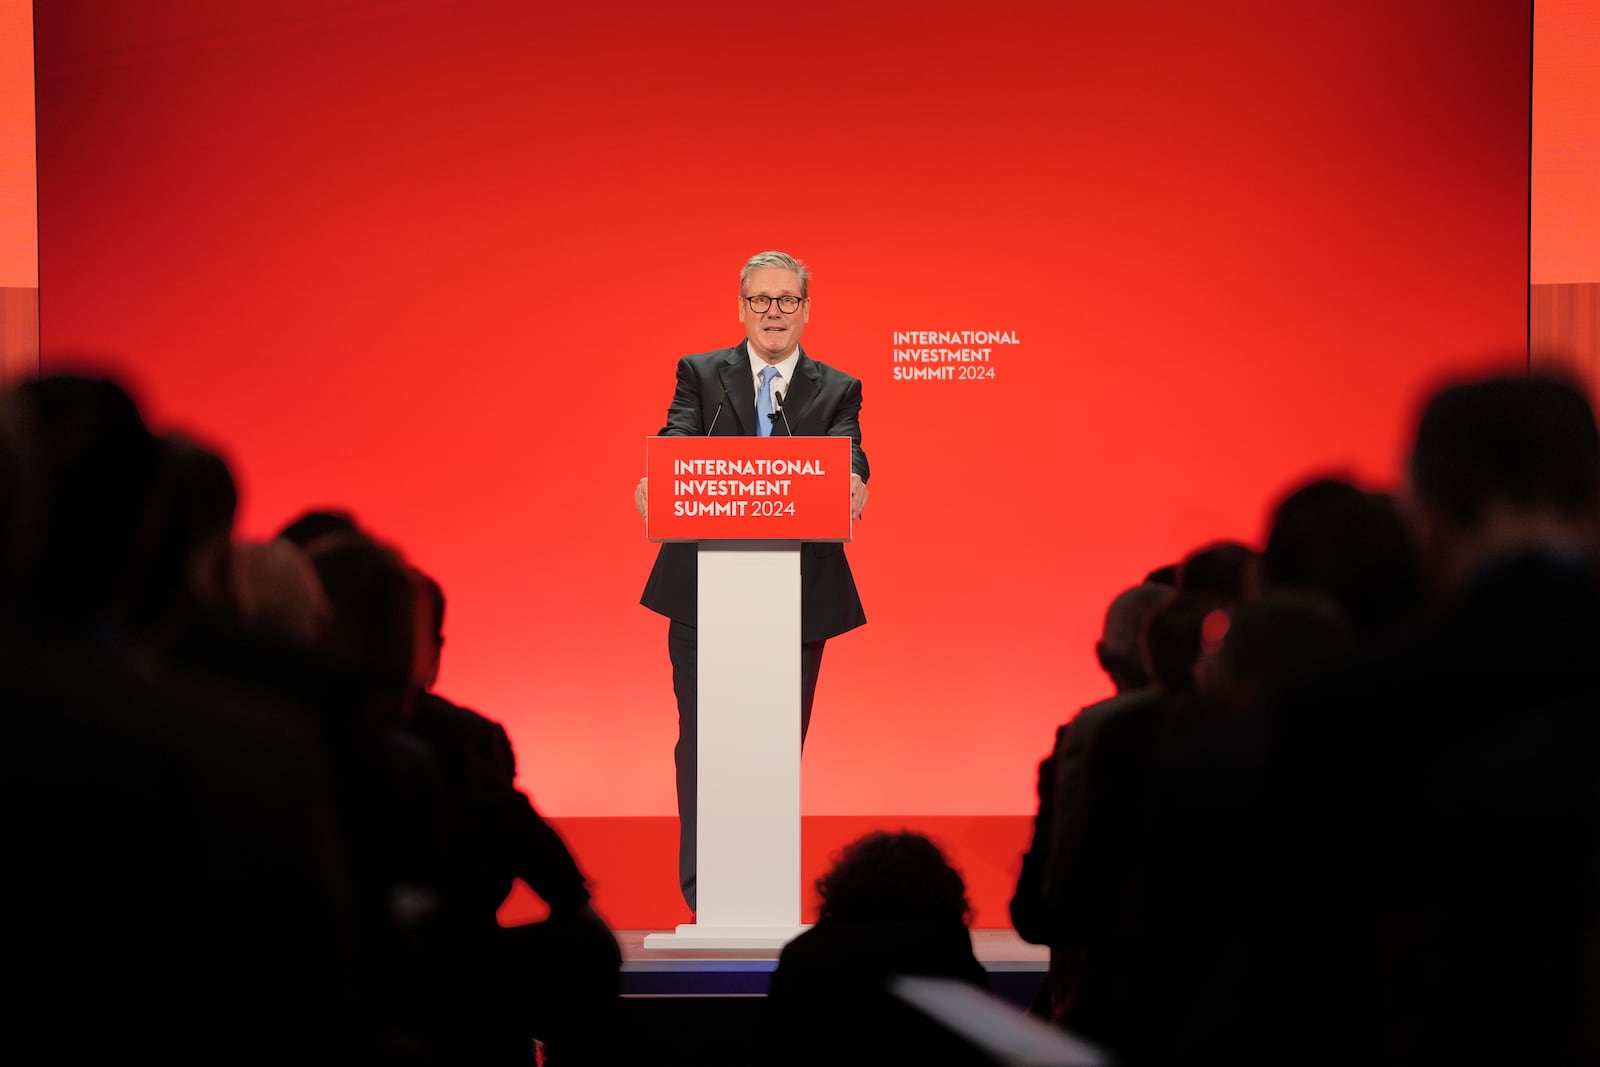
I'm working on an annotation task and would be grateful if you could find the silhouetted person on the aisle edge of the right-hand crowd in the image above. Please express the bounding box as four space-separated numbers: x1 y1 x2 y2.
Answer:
1010 581 1173 1017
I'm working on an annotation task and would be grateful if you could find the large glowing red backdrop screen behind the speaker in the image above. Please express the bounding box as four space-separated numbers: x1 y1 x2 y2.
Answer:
37 0 1531 816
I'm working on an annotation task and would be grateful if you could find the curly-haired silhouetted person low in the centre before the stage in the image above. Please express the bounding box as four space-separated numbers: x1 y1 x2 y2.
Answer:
768 830 990 1064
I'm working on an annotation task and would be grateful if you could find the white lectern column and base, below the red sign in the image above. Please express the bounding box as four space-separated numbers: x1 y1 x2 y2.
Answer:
645 541 803 949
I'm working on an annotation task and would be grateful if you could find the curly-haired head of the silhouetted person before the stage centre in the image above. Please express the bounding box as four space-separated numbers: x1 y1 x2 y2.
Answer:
816 830 971 925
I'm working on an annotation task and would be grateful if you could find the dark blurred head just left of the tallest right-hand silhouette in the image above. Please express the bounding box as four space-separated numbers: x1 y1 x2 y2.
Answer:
1259 475 1422 640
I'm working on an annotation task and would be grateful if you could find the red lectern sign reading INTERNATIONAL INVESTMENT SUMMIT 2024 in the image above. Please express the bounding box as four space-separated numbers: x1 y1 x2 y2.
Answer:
645 437 850 541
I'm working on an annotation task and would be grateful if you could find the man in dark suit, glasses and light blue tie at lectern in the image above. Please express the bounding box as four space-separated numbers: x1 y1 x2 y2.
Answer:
634 251 870 910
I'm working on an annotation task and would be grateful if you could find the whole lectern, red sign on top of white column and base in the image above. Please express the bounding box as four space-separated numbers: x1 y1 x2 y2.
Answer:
645 437 851 949
